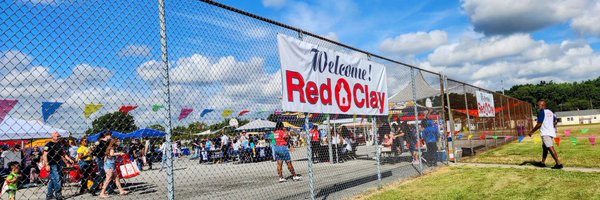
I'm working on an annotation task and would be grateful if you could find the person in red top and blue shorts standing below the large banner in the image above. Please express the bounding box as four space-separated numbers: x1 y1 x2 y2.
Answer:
273 122 302 182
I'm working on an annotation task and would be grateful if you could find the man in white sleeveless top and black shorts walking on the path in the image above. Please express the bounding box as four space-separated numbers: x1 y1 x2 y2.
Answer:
529 100 563 169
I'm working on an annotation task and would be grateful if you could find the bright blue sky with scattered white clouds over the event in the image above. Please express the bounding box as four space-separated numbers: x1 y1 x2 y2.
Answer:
0 0 600 131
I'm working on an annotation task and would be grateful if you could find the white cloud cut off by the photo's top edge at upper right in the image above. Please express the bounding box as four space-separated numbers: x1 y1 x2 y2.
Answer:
462 0 593 35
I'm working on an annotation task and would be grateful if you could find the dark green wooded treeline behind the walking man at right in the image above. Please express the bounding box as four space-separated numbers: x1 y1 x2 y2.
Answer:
505 77 600 111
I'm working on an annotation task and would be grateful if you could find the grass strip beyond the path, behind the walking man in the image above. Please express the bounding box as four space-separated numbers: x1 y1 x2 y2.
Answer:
463 124 600 168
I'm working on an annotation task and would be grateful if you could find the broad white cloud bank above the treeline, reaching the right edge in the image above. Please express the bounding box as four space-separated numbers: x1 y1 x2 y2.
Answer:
418 34 600 90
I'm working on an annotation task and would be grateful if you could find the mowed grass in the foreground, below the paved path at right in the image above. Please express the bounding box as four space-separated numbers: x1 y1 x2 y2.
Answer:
356 167 600 200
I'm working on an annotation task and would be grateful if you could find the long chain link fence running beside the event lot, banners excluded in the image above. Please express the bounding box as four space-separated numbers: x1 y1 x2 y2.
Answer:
0 0 532 199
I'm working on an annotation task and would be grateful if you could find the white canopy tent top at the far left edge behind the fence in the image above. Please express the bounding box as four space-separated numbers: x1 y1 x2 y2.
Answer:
0 117 68 140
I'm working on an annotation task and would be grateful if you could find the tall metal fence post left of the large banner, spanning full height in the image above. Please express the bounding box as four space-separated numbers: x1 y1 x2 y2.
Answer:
158 0 175 200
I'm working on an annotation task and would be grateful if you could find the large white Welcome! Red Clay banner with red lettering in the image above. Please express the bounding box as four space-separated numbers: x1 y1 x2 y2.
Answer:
277 34 388 115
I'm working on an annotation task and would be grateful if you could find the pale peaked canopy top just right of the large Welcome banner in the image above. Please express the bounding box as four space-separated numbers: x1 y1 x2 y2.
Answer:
388 73 442 102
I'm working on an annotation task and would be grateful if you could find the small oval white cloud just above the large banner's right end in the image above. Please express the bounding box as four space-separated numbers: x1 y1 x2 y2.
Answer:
379 30 448 54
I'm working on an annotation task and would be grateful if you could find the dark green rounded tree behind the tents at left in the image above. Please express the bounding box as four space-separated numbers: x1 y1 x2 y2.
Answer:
85 112 138 135
